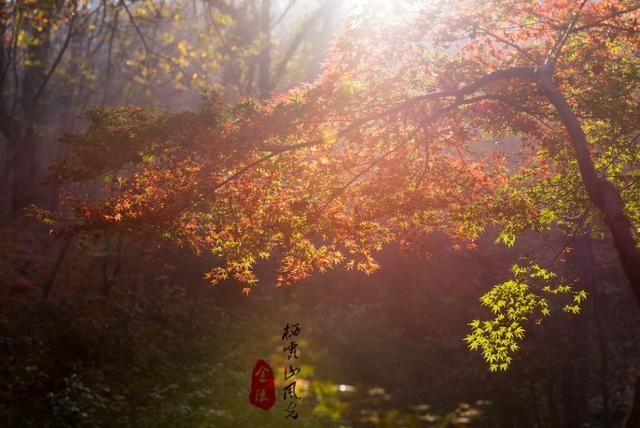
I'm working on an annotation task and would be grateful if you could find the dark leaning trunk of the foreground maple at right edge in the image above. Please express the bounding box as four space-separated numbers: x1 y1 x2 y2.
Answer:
537 66 640 428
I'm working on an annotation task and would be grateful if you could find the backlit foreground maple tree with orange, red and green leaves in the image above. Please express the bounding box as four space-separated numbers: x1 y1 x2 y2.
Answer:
40 0 640 426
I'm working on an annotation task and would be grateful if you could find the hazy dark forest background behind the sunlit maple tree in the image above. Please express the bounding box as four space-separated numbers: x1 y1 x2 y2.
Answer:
0 0 640 427
